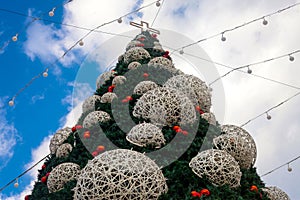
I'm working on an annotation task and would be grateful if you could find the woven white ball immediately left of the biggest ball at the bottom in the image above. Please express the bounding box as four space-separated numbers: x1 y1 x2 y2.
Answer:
47 163 80 193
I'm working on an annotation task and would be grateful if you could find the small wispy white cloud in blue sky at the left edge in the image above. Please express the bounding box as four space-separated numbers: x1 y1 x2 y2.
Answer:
0 97 20 170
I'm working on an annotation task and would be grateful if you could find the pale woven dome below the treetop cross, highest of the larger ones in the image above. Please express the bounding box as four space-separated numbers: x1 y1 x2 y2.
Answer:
124 47 151 63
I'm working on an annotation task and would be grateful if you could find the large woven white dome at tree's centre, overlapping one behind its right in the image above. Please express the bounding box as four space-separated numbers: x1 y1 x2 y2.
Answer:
133 87 196 126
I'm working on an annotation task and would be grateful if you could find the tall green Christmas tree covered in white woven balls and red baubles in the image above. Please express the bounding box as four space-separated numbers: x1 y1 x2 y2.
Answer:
26 23 289 200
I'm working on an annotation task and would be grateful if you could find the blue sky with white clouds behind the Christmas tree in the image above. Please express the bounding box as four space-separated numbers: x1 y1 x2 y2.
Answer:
0 0 300 200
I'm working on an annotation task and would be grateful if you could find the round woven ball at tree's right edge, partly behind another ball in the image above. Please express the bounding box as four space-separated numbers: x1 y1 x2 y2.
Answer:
213 125 256 169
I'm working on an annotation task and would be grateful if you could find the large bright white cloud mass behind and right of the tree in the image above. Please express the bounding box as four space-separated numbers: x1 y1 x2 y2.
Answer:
9 0 300 199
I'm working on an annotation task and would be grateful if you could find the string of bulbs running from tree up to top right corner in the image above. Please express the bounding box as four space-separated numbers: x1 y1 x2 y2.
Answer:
172 2 300 53
